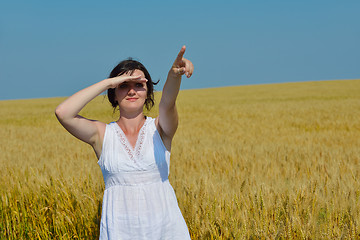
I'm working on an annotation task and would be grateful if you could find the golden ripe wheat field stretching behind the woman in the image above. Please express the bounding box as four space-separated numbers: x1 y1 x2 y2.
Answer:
0 80 360 239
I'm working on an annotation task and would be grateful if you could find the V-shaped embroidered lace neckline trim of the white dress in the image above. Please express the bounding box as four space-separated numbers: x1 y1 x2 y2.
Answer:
114 118 149 163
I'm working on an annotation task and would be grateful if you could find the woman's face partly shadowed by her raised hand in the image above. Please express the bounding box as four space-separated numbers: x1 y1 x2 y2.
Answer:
115 69 148 112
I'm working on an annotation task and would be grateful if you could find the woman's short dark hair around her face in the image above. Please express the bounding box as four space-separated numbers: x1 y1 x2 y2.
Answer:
107 58 159 110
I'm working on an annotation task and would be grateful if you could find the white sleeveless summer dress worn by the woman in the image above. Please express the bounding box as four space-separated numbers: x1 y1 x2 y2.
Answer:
98 117 190 240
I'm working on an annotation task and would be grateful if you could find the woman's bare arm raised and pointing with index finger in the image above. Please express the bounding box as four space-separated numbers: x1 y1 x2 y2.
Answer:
157 46 194 150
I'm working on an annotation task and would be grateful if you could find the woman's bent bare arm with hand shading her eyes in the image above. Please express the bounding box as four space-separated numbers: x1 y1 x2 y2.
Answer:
55 75 145 156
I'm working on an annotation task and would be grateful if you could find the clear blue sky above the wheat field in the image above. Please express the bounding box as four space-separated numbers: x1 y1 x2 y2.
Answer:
0 0 360 99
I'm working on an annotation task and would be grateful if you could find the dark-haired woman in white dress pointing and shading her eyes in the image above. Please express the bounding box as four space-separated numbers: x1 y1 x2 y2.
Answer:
55 46 194 239
